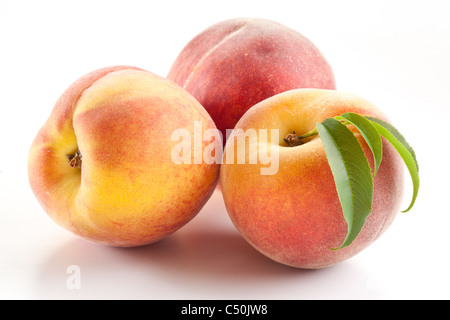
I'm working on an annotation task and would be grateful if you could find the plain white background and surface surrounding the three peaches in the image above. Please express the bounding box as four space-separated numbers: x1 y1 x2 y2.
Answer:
0 0 450 299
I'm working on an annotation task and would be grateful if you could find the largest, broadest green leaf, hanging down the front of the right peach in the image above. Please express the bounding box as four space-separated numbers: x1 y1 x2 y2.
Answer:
317 118 373 250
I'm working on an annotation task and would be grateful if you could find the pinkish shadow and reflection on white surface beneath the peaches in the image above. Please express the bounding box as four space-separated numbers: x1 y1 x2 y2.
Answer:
29 191 377 299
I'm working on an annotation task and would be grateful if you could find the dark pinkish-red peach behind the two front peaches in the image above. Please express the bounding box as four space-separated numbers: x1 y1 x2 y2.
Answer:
167 18 335 142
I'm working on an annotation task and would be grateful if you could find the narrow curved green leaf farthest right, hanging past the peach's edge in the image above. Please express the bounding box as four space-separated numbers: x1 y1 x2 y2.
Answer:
366 117 420 212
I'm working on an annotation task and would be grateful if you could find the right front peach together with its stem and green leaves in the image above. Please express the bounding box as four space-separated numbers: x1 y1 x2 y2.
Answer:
220 89 419 269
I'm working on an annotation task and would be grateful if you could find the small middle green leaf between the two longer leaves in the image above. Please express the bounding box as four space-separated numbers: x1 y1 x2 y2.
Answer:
335 112 383 177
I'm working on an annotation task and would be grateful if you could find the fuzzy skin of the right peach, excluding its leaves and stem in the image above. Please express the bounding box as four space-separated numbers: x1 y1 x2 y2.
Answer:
220 89 404 269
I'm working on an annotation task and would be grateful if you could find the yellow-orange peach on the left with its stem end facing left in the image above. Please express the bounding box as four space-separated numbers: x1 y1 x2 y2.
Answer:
28 66 219 247
